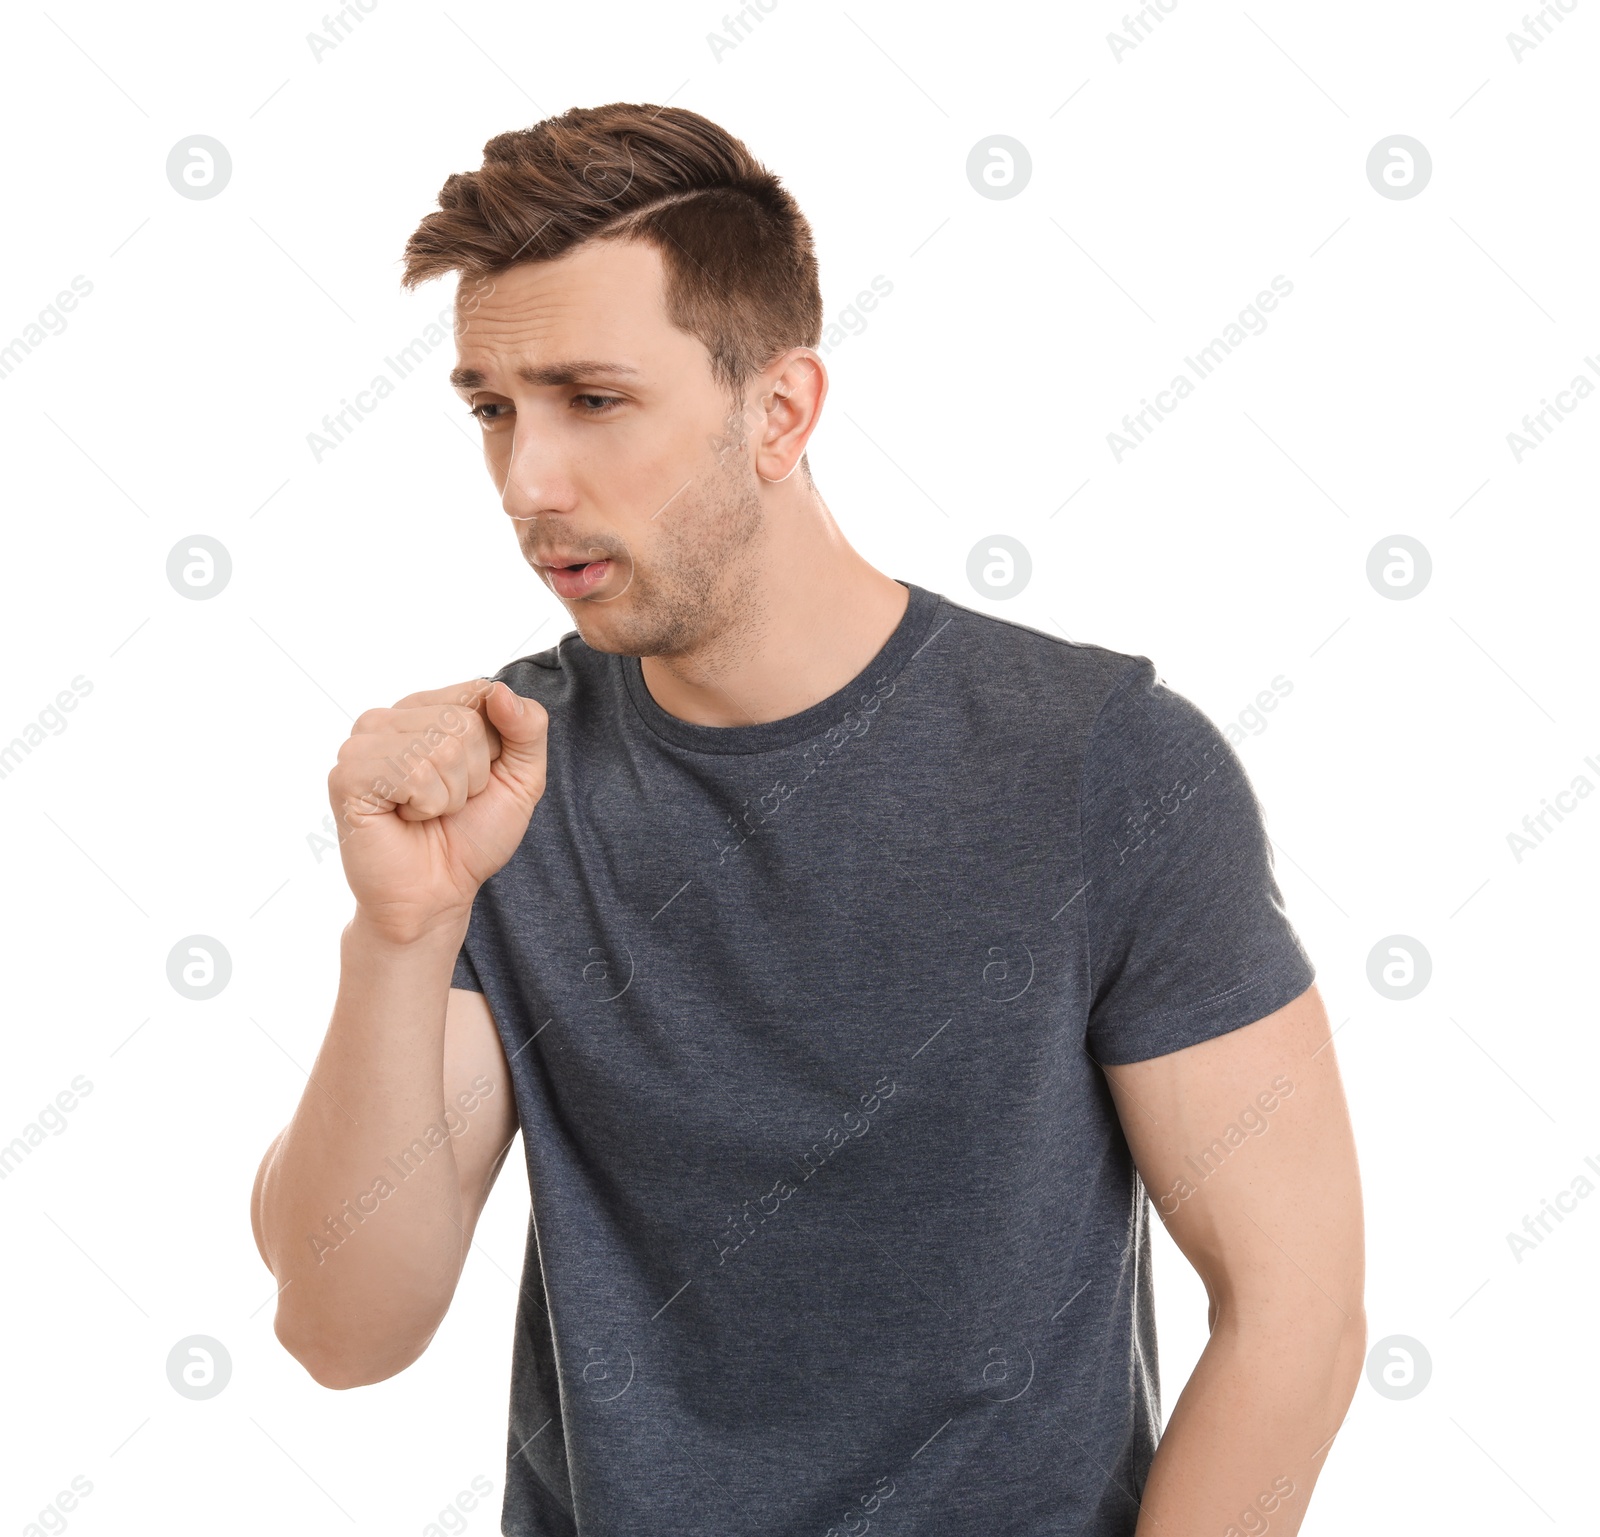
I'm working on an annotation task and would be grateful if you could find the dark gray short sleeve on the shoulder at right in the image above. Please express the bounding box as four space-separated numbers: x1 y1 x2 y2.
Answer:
1082 657 1315 1064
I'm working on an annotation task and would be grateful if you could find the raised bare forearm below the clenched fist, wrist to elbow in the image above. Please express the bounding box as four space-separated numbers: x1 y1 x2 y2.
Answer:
256 913 466 1387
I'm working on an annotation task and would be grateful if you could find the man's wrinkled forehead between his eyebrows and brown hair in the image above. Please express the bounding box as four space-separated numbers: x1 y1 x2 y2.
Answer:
456 240 704 376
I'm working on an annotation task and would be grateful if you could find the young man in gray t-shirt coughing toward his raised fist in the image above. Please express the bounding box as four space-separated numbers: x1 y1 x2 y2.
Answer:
253 104 1365 1537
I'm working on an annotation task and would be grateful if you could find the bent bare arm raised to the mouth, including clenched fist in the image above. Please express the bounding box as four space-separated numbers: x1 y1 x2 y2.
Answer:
251 680 547 1388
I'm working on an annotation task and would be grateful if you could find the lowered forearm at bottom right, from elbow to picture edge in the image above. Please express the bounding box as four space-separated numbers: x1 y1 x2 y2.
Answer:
1136 1313 1366 1537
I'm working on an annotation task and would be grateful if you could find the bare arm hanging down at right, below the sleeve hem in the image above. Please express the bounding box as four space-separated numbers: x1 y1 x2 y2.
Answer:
1106 987 1366 1537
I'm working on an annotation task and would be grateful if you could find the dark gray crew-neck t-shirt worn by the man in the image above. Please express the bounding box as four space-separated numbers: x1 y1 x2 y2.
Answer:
454 582 1314 1537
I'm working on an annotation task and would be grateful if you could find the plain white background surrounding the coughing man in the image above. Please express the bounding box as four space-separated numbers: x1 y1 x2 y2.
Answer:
0 0 1600 1537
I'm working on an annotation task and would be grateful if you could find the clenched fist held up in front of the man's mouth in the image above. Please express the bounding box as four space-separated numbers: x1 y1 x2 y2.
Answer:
328 678 550 940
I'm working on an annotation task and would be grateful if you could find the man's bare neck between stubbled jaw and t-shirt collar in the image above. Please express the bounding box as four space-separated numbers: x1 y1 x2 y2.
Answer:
640 492 910 726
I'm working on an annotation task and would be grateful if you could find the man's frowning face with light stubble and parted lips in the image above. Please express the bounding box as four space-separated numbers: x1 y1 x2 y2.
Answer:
451 242 763 656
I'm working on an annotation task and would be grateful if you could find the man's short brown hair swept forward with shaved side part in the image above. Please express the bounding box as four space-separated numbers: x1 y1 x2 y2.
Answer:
400 102 822 409
